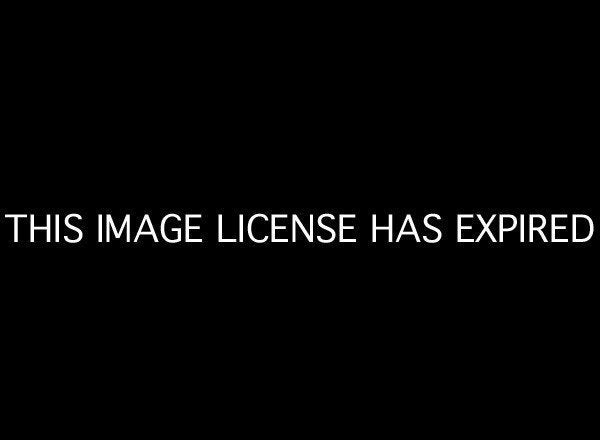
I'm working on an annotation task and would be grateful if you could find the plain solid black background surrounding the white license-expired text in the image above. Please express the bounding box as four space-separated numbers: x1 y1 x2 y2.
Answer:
1 5 598 433
